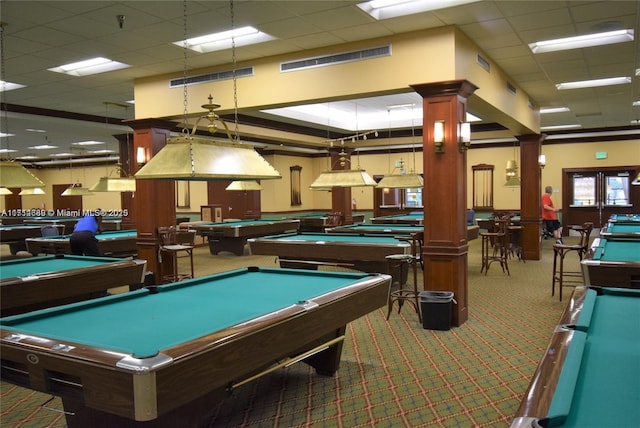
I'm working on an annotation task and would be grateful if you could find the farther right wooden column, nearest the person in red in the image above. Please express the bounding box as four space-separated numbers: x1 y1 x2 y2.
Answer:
516 134 546 260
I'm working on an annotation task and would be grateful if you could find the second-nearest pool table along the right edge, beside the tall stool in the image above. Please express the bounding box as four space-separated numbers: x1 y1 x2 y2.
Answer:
581 237 640 288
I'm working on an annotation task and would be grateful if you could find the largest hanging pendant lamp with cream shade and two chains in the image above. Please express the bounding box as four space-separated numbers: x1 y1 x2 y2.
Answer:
135 0 282 181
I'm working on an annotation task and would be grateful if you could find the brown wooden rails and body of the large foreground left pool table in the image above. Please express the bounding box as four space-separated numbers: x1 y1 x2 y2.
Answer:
0 275 391 428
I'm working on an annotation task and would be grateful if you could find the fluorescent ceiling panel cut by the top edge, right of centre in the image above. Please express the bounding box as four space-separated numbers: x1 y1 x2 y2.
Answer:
358 0 478 20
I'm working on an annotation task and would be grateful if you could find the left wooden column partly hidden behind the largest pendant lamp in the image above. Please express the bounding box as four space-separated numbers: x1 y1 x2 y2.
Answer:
127 119 176 283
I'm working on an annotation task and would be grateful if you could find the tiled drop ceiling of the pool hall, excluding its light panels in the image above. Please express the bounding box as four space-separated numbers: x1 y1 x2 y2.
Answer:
0 0 640 161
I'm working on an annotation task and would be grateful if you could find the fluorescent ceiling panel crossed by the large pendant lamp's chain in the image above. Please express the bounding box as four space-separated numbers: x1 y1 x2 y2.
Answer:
173 26 275 53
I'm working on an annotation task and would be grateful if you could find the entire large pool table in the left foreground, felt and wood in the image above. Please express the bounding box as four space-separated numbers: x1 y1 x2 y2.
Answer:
0 267 390 428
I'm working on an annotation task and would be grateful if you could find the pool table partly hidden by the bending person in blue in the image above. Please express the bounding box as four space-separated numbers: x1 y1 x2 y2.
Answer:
25 229 138 257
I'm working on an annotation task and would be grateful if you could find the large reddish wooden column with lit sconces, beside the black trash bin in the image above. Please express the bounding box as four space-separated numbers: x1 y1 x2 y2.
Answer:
411 80 477 326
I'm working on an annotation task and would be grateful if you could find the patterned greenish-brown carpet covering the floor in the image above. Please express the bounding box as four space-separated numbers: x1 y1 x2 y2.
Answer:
0 238 578 428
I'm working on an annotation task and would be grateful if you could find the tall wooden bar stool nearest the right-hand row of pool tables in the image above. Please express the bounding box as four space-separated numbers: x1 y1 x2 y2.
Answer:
551 222 593 301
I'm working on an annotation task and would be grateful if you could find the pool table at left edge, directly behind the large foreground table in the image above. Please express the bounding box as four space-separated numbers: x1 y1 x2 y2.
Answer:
0 254 146 317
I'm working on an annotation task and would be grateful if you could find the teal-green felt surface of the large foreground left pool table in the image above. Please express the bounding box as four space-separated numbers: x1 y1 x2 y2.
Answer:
0 269 368 358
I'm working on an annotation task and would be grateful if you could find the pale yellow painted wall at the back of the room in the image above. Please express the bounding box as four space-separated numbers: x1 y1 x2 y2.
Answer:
6 140 640 213
